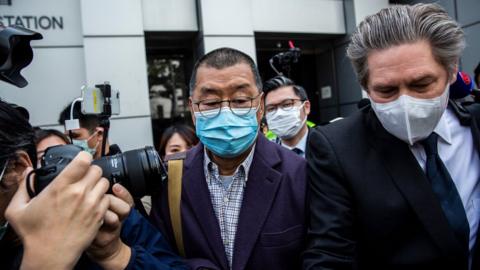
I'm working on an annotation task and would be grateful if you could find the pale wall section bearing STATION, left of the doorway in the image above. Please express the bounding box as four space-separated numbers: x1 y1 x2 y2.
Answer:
0 0 152 150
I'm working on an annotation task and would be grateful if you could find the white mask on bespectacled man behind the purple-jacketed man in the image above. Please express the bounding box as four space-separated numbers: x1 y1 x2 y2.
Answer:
265 102 307 140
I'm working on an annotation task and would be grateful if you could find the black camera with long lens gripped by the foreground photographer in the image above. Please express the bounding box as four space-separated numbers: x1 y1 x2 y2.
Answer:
27 144 167 198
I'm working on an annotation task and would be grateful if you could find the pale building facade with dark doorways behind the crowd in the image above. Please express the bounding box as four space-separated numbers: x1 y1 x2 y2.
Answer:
0 0 480 150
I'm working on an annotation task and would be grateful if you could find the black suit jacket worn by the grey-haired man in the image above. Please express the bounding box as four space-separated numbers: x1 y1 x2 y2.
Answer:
303 106 480 270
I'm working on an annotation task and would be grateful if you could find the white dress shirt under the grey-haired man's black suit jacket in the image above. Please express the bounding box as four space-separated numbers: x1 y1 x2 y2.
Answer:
410 109 480 263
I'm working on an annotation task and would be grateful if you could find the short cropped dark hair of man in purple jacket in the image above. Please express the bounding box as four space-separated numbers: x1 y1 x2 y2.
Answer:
189 47 262 95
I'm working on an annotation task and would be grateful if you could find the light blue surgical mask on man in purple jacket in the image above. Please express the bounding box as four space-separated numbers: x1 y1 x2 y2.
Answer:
195 107 258 158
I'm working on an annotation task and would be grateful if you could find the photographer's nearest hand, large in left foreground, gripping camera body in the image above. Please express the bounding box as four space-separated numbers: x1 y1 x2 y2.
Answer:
5 152 110 269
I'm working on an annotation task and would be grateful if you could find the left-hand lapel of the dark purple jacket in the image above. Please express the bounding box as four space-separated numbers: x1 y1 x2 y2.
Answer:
182 147 228 269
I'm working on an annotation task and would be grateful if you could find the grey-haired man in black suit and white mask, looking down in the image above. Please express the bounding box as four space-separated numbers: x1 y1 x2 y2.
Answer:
304 4 480 270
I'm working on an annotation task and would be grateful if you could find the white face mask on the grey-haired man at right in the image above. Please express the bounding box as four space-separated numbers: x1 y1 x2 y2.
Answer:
370 85 449 145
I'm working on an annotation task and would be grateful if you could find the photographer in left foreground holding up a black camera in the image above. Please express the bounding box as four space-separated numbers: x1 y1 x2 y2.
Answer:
0 101 188 269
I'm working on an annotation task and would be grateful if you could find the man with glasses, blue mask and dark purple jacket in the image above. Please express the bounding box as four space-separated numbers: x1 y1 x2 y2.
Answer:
151 48 308 269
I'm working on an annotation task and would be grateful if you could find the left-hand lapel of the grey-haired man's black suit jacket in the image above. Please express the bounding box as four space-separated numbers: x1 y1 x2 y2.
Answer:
367 110 463 256
